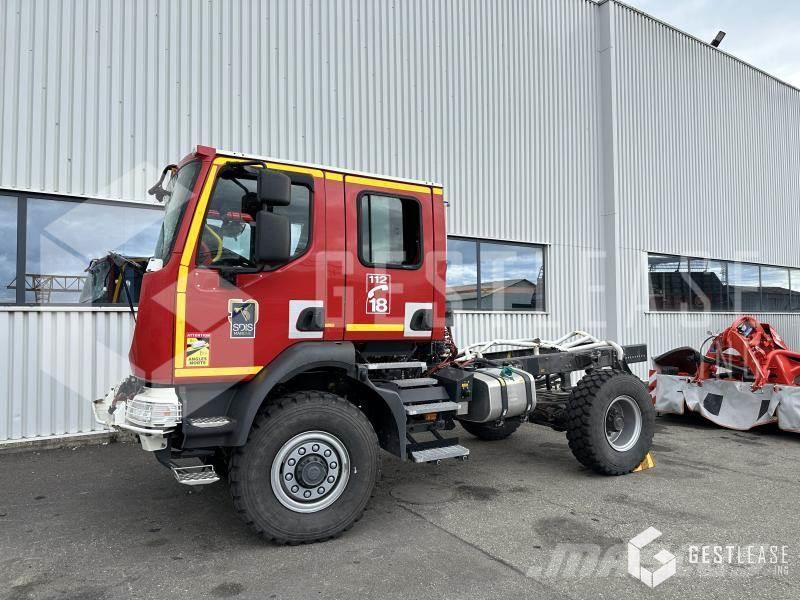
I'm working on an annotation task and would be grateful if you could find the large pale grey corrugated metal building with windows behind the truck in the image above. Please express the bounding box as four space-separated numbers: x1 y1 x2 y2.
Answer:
0 0 800 441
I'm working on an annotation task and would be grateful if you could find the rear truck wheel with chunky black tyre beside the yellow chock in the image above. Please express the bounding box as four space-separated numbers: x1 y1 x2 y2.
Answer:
567 370 655 475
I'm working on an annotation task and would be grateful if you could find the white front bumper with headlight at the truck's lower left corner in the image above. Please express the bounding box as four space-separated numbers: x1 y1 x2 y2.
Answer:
92 387 181 452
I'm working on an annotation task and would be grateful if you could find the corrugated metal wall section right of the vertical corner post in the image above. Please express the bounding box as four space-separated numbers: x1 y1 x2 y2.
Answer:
600 3 800 372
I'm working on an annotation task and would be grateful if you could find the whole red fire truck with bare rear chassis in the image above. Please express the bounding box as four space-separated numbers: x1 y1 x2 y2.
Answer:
94 146 654 543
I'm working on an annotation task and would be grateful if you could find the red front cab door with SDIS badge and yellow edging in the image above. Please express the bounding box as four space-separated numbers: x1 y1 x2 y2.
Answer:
175 158 327 380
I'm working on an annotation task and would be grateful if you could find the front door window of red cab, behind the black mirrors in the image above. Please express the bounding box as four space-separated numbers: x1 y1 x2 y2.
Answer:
197 168 311 268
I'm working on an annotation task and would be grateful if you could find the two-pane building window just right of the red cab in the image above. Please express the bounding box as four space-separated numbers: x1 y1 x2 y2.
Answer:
447 237 545 311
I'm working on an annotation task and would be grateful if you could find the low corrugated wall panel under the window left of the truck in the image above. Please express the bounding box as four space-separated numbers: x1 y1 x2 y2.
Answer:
0 309 132 441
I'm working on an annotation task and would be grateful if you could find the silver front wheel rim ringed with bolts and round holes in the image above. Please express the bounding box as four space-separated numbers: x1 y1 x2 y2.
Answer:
270 431 350 513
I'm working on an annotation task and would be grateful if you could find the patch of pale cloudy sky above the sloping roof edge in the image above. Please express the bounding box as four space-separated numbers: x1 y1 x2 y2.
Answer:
623 0 800 87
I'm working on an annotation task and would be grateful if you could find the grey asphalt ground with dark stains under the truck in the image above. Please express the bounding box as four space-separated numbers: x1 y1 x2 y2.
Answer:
0 417 800 600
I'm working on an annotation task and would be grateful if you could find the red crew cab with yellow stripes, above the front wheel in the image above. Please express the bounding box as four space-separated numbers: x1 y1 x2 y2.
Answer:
130 147 446 385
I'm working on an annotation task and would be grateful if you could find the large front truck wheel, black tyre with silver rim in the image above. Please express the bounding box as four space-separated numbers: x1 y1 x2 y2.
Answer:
228 391 380 544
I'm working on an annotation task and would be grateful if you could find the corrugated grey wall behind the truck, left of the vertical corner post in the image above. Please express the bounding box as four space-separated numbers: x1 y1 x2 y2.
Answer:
0 0 603 439
